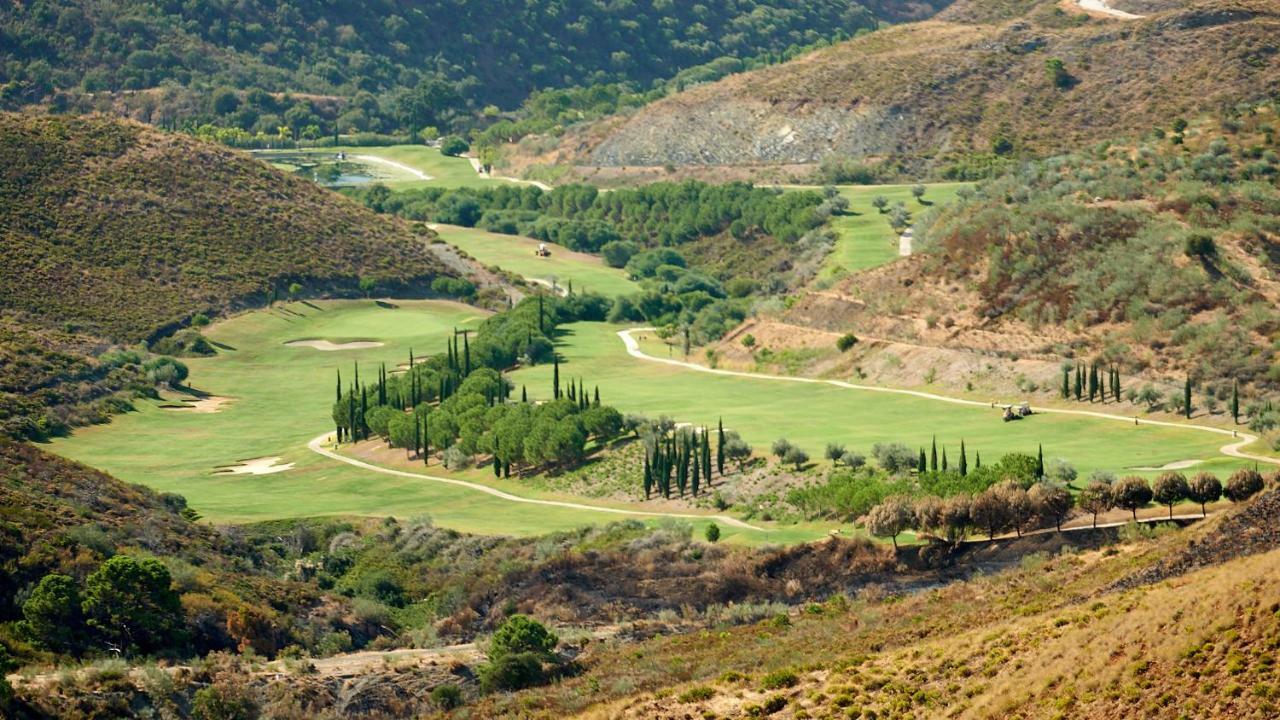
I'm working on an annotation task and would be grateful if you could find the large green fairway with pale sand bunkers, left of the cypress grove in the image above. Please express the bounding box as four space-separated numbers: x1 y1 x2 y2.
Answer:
50 300 824 543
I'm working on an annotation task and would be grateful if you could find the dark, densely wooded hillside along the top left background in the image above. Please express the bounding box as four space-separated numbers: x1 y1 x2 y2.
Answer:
0 0 943 140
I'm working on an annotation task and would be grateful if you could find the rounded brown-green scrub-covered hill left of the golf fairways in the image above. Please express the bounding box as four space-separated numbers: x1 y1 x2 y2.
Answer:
0 114 474 437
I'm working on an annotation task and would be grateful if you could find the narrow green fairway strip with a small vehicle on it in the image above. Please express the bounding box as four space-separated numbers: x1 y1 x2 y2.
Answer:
436 225 639 296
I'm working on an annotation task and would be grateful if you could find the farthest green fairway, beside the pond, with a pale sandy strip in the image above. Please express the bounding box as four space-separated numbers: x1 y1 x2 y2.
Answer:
253 145 511 190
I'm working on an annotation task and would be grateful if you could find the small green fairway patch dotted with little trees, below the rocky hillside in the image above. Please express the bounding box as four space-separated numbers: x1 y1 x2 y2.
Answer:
788 182 973 278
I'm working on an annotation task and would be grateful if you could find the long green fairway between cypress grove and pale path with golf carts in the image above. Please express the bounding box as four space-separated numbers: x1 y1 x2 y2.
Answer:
512 323 1252 478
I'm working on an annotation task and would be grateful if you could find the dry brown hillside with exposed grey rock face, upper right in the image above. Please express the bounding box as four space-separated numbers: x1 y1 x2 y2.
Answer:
543 0 1280 174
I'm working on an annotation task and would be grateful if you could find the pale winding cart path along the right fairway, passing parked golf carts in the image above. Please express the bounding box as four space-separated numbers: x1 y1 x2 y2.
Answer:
618 328 1280 465
